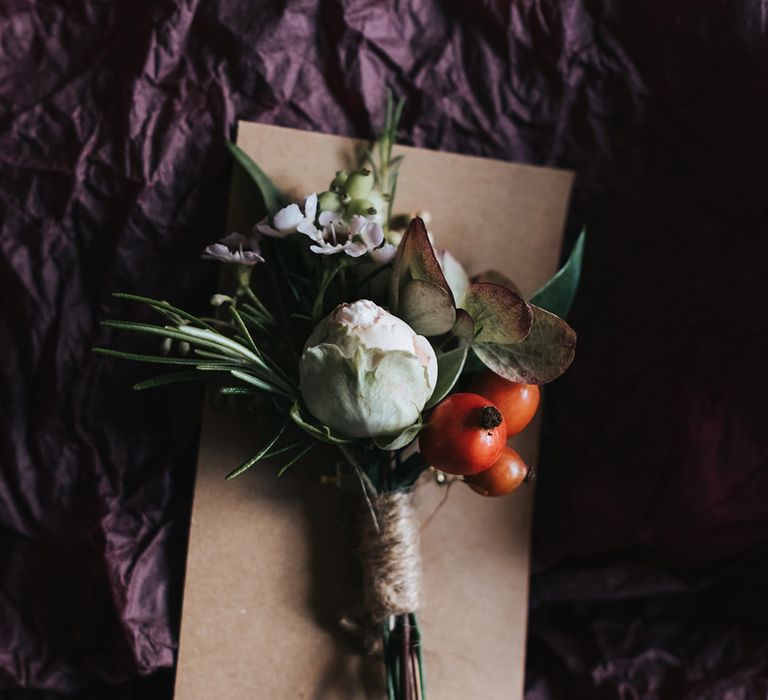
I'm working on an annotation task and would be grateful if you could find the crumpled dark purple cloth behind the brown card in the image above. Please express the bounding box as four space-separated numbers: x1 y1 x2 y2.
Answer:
0 0 768 700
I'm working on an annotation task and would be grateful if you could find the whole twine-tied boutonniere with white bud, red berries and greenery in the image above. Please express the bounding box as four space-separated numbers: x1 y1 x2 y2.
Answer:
97 98 584 700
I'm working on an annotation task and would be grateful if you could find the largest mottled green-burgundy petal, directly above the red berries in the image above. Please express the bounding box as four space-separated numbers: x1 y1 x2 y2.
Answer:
472 305 576 384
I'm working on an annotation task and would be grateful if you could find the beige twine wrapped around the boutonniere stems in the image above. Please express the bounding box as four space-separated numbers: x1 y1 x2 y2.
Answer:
360 493 422 622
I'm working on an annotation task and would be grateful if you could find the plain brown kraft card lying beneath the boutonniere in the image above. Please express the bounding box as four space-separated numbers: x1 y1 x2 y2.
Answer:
176 122 573 700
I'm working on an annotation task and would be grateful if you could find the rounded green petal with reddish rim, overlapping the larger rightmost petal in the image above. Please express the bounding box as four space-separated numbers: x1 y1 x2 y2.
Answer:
464 282 533 344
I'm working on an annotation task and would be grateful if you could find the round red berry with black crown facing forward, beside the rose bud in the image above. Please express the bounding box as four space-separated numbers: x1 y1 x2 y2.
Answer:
419 394 507 474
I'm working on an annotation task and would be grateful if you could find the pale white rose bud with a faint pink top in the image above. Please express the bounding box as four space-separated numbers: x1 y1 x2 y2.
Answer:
299 299 437 438
